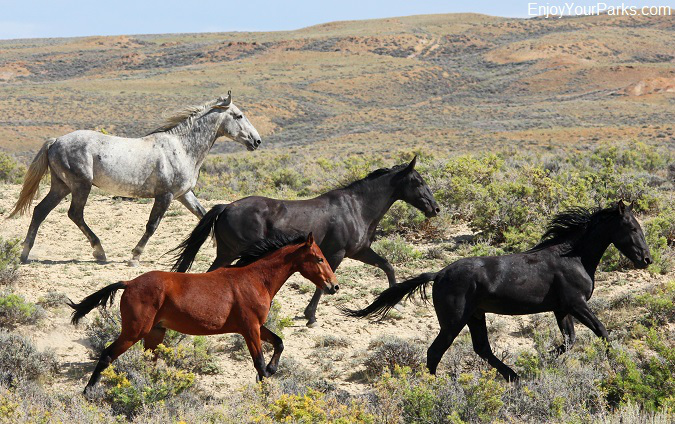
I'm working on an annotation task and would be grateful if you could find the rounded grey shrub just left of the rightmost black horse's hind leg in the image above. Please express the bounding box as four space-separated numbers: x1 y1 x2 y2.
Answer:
364 337 424 378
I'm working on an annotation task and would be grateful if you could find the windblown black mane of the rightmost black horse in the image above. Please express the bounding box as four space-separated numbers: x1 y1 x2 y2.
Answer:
528 206 616 252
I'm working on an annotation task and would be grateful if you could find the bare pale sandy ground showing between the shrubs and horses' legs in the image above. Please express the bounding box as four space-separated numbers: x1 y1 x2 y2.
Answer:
0 185 664 396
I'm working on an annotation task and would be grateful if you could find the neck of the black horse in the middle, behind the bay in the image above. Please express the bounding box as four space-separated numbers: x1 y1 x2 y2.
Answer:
347 175 399 222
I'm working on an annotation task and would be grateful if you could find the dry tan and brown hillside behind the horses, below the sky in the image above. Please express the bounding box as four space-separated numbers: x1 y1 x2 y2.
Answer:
0 14 675 161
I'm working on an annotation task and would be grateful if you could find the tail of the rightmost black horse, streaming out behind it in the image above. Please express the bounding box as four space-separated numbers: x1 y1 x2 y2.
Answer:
340 272 438 320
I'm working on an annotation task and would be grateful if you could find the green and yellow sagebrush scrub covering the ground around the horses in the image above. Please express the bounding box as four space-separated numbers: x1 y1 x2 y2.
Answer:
0 137 675 423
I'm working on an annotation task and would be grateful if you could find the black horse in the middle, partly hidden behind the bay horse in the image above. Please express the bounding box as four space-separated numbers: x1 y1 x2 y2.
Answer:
173 157 440 326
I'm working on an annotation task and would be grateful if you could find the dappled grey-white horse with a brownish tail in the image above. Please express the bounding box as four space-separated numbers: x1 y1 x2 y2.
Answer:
9 92 260 266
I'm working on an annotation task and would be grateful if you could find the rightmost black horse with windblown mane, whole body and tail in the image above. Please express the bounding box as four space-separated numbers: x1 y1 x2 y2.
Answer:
343 201 652 381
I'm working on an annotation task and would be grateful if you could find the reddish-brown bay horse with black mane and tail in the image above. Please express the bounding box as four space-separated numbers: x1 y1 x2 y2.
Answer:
68 233 339 393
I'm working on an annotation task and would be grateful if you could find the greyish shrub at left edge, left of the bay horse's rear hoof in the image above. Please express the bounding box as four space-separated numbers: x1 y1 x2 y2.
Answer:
0 330 58 384
